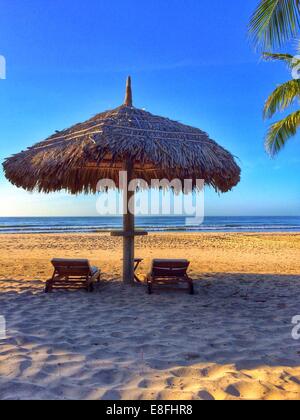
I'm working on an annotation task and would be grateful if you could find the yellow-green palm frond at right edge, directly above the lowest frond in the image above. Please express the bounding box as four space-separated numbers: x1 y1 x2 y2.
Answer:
264 80 300 118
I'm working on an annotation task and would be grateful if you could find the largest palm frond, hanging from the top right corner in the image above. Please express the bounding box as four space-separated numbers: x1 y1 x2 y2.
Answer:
249 0 300 50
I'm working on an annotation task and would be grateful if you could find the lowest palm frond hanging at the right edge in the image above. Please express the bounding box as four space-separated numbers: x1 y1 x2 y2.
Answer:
265 111 300 156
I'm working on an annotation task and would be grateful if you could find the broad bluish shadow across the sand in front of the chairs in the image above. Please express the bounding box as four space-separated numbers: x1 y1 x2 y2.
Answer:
0 273 300 399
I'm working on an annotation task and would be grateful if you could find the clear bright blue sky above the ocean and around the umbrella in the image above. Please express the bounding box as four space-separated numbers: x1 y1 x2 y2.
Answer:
0 0 300 216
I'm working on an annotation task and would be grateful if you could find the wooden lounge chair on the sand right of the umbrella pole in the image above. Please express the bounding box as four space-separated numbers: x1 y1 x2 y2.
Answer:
147 260 194 295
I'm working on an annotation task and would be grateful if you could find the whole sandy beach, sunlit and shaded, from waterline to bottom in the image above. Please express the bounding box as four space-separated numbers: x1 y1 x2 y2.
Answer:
0 233 300 400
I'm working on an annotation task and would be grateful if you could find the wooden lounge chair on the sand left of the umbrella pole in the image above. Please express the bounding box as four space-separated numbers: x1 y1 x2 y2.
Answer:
45 259 101 293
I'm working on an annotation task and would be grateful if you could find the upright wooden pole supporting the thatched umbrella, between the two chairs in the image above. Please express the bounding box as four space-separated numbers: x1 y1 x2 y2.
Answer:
123 160 135 284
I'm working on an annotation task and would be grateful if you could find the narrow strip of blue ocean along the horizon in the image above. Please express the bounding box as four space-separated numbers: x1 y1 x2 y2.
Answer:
0 216 300 234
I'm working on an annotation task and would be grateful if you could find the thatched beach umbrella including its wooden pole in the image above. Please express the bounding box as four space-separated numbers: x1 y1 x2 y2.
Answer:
3 78 240 283
